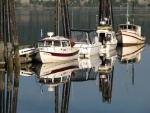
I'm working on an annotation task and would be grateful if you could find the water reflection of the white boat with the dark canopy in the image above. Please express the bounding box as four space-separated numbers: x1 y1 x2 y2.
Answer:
71 55 101 81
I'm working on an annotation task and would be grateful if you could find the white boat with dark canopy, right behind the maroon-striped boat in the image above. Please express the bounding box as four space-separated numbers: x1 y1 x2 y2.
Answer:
72 30 101 58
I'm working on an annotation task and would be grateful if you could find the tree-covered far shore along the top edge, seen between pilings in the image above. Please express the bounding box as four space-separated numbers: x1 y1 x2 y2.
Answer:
15 0 147 7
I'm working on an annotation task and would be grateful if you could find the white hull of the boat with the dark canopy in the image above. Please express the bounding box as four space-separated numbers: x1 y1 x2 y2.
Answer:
74 43 101 57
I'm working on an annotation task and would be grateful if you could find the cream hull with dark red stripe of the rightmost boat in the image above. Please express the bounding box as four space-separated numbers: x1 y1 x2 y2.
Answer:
116 30 145 45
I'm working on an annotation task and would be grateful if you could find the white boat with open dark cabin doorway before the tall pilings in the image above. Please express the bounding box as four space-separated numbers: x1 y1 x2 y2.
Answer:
96 25 117 53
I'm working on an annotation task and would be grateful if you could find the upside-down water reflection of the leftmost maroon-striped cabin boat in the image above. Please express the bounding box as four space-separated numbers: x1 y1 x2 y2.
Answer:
35 60 78 91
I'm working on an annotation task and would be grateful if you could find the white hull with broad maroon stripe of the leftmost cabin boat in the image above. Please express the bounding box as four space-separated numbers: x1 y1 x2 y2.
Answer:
35 50 79 63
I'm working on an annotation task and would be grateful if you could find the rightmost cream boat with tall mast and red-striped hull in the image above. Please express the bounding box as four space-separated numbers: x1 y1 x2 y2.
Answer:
116 3 146 46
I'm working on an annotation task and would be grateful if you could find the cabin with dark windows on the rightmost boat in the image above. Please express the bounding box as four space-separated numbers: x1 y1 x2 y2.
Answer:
119 24 141 36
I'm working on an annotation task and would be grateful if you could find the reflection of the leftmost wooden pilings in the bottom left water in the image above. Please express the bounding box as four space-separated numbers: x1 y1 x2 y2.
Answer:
0 65 20 113
